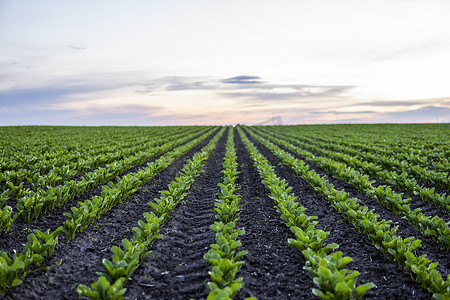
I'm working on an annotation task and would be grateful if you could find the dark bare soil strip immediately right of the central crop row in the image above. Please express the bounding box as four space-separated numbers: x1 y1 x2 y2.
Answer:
235 134 315 299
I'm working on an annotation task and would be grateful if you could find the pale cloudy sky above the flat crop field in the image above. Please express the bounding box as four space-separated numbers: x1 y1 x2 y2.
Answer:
0 0 450 126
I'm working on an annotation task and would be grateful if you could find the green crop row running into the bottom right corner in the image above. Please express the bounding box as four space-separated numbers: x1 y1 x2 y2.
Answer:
244 127 450 299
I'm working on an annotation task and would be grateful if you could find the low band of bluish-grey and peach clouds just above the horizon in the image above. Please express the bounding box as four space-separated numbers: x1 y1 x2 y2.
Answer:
0 73 450 125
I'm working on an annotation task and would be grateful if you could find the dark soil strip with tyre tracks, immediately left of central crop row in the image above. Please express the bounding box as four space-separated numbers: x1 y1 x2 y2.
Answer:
125 127 227 299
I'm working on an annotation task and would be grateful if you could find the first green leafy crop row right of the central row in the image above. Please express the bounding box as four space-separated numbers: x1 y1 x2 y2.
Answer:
238 128 374 299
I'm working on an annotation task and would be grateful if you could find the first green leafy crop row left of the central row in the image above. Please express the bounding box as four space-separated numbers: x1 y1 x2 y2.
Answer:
77 128 225 299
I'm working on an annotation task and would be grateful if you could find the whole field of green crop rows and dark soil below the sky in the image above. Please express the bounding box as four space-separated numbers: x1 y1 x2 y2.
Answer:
0 124 450 299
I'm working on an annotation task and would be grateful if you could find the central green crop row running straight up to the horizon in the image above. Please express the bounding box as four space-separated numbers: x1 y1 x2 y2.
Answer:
203 127 248 300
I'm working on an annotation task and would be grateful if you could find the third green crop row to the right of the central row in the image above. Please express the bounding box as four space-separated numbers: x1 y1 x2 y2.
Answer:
250 127 450 249
